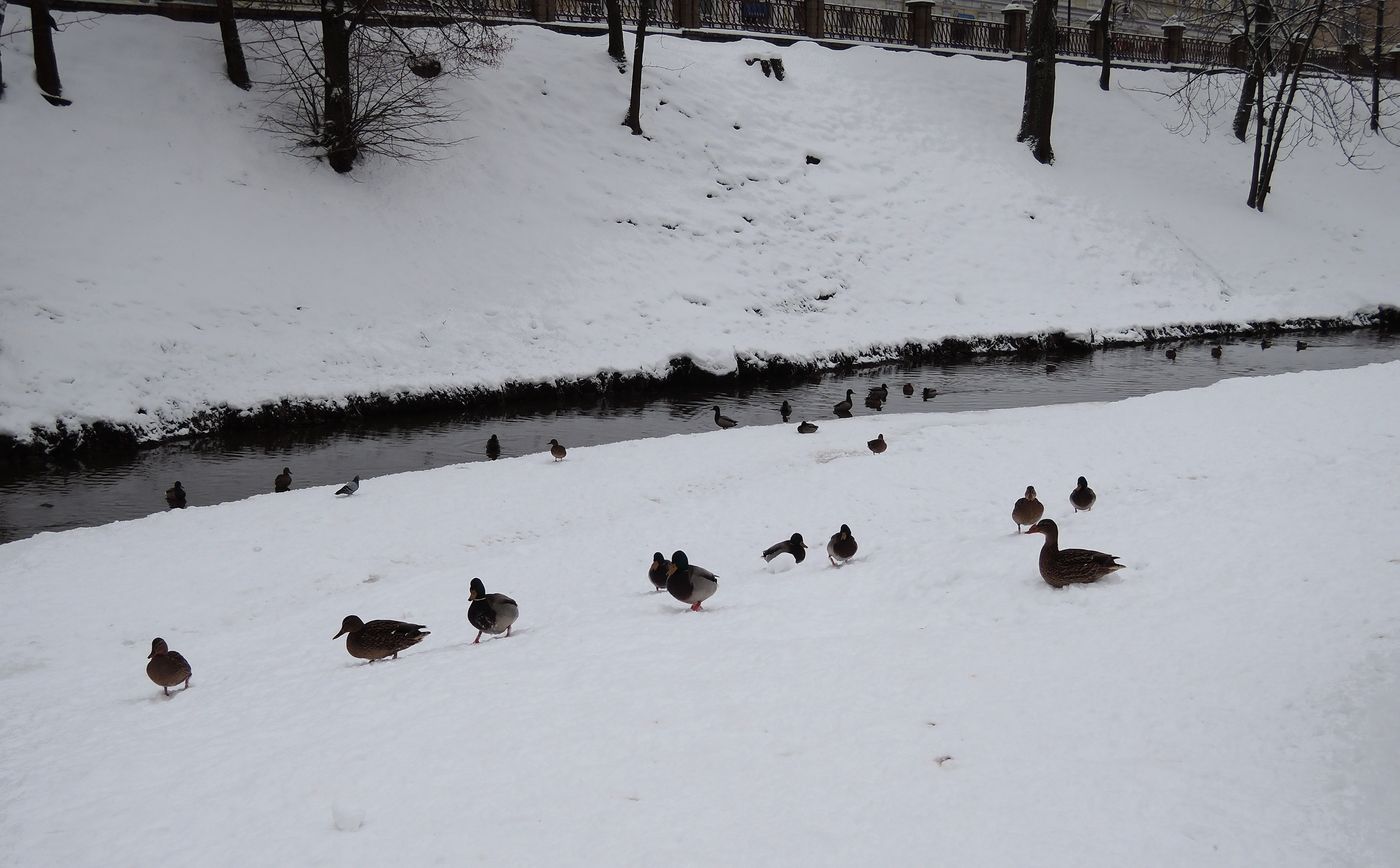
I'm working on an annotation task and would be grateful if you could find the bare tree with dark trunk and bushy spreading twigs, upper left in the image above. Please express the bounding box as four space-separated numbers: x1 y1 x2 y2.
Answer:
251 0 510 172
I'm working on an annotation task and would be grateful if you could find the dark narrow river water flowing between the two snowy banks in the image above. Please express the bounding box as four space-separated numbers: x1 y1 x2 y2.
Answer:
0 330 1400 543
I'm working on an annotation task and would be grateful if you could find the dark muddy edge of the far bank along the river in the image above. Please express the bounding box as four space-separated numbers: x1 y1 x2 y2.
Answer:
0 307 1400 469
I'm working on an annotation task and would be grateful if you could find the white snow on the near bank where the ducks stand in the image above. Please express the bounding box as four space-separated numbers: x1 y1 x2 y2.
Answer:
0 363 1400 868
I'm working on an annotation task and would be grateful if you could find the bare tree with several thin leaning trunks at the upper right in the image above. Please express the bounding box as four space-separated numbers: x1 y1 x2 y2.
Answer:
1169 0 1397 211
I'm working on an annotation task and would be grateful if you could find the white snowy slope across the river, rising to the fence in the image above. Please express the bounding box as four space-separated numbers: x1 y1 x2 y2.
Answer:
0 15 1400 438
